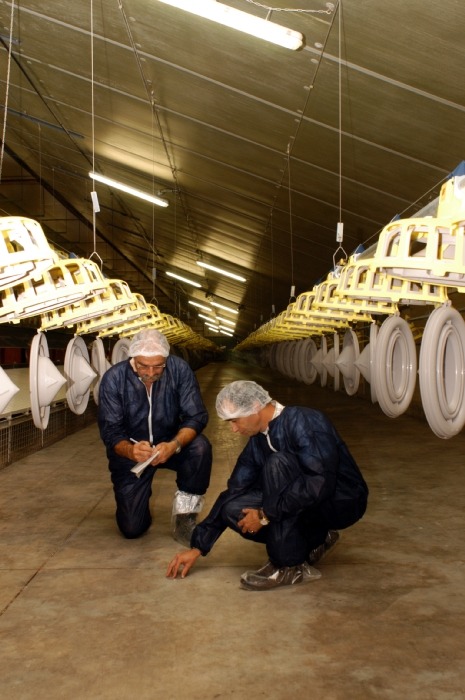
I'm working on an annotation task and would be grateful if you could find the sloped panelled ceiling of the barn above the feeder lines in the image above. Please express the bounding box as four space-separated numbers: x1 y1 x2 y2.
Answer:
0 0 465 340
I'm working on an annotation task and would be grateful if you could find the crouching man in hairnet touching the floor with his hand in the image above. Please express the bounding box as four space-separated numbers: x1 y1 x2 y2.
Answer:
167 381 368 591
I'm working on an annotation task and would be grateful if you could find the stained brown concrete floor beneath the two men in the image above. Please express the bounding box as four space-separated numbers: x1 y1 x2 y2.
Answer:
0 364 465 700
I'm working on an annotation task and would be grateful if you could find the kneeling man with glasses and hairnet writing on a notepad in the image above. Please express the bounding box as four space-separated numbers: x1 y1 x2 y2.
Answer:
98 329 212 547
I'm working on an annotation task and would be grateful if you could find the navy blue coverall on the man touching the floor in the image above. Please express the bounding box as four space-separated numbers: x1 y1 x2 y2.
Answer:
191 406 368 567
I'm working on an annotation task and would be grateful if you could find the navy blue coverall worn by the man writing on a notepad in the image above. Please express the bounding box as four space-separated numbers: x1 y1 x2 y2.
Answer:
98 355 212 538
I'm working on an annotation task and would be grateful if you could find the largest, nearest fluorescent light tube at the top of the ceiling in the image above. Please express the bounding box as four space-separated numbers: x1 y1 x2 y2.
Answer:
156 0 304 51
